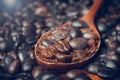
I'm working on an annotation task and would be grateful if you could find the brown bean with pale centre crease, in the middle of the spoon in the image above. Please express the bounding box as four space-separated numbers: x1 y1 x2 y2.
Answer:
55 40 71 53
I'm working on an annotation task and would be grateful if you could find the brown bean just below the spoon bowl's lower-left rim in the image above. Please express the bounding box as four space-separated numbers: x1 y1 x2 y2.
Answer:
32 66 45 79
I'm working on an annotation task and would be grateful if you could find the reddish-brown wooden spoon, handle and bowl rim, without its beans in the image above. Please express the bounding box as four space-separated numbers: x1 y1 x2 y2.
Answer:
34 0 103 72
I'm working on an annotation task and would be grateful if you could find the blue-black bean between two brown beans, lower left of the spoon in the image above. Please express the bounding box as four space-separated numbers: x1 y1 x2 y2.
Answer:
22 59 34 72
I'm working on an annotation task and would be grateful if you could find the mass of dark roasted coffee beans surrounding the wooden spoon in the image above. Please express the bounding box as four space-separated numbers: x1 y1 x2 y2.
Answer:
0 0 120 80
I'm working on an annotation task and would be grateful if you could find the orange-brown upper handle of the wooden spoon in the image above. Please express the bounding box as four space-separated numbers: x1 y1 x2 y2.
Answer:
80 0 103 22
